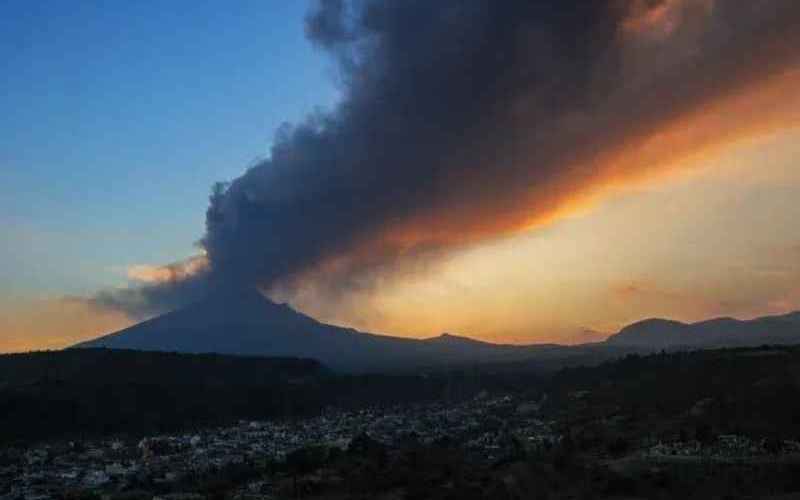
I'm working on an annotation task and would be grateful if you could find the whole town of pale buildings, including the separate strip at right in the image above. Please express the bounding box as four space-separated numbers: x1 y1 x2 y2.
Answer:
7 386 800 500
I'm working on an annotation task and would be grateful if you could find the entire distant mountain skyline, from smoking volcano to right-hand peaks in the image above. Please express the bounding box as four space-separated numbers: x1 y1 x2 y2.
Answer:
73 289 800 372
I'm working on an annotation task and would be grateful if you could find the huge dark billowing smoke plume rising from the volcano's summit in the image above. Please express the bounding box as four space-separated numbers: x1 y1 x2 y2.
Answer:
98 0 800 314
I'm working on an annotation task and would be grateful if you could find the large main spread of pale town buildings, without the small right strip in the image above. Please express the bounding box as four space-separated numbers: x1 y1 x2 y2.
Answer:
0 394 557 500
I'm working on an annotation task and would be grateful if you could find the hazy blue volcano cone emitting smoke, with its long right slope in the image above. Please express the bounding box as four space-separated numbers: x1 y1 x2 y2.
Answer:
75 289 538 372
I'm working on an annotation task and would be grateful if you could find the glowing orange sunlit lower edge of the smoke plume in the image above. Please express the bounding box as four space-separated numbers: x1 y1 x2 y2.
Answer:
362 69 800 260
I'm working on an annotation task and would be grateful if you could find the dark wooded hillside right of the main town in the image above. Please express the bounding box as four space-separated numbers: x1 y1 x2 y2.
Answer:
547 346 800 442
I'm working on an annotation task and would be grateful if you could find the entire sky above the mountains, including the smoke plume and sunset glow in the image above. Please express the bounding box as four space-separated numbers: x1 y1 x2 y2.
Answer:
0 0 800 352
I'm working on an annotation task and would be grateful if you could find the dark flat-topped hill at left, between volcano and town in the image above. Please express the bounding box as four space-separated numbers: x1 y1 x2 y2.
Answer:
0 349 320 442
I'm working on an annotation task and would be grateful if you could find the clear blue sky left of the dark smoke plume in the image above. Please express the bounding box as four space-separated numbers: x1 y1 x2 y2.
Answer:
0 0 337 297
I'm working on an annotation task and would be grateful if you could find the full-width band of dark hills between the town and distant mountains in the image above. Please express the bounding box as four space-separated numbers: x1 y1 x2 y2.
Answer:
0 346 800 456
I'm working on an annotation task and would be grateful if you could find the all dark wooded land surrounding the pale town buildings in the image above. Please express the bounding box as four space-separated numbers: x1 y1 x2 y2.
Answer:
6 346 800 499
